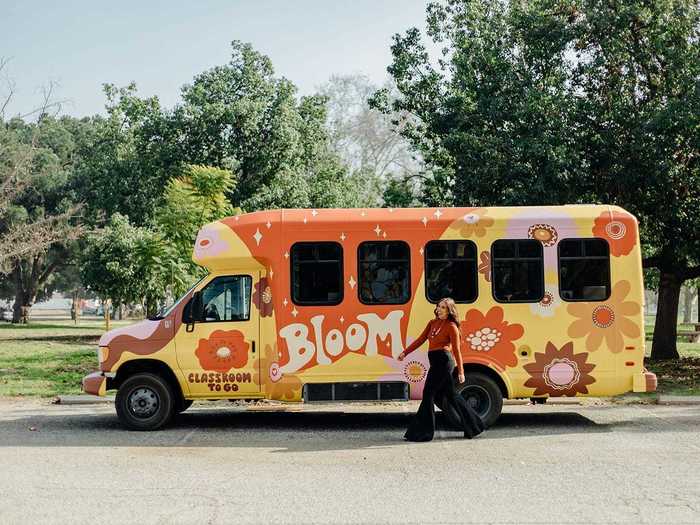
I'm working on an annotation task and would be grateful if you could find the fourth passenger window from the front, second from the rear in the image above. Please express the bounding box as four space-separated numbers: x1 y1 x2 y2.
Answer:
491 239 544 303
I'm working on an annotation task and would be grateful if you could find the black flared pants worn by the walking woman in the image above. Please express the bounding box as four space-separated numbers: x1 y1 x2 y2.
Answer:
404 350 484 441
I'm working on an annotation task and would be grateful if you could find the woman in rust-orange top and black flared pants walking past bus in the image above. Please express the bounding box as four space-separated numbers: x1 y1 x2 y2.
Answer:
398 297 484 441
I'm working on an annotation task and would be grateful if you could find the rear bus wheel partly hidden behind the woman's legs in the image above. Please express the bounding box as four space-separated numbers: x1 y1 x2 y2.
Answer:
435 372 503 429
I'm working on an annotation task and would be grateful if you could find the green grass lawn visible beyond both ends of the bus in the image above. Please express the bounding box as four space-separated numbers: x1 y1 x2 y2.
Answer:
0 320 700 397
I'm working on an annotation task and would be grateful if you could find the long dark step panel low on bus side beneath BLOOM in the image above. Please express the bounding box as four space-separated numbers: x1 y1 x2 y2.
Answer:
302 381 408 402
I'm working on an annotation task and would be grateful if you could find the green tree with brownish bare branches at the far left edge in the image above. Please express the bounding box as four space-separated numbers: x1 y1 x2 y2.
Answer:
0 113 89 322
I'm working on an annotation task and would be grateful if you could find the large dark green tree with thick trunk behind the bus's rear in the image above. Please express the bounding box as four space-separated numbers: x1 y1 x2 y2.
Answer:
373 0 700 359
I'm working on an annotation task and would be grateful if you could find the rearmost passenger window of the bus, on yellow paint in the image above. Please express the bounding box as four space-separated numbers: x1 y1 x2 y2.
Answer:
558 239 610 301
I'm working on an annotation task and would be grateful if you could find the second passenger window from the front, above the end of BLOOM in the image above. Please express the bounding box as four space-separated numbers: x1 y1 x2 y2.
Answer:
357 241 411 304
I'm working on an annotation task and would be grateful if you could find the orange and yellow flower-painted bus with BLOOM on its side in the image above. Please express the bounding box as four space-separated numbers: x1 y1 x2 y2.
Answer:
83 205 656 430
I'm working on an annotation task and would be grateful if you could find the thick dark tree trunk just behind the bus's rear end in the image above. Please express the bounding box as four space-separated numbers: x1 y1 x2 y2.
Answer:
651 271 682 360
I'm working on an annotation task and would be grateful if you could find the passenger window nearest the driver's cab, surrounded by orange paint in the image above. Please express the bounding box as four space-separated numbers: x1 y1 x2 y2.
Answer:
291 242 343 305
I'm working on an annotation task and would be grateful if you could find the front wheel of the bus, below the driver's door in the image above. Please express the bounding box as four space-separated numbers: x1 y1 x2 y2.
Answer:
115 373 175 430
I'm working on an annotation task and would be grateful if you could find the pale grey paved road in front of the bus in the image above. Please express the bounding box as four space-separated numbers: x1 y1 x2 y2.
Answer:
0 400 700 524
